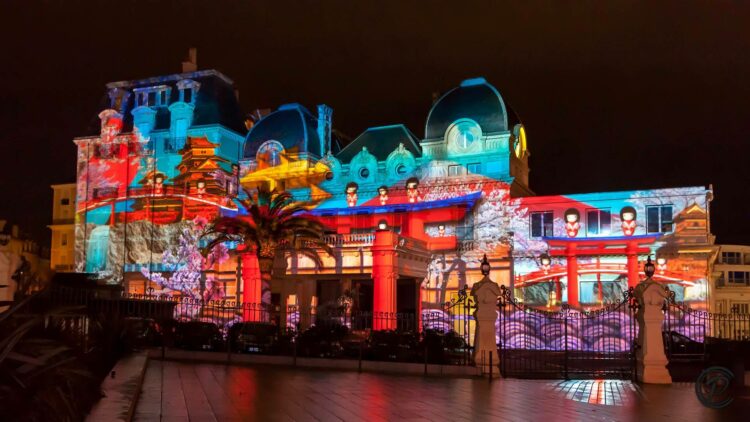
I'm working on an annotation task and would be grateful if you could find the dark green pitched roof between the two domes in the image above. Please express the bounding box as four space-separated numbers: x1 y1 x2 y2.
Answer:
336 124 422 163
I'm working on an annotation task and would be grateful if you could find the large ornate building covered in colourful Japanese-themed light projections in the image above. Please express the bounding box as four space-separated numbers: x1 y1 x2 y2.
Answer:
75 71 714 320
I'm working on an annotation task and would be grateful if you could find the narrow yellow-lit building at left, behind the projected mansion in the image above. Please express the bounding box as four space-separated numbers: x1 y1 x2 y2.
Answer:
47 183 76 272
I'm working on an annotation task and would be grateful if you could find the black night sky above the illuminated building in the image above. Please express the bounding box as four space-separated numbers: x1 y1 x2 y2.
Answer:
0 0 750 244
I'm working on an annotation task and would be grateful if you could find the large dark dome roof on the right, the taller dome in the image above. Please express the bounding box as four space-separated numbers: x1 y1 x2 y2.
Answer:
425 78 508 139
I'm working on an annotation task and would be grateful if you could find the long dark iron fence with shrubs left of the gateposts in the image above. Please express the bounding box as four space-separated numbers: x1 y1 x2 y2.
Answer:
27 287 472 365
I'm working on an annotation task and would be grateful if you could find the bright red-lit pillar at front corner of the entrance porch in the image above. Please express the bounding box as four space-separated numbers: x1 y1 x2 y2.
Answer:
371 230 398 330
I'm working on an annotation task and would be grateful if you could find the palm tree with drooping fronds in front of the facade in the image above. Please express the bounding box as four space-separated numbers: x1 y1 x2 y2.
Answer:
202 188 333 303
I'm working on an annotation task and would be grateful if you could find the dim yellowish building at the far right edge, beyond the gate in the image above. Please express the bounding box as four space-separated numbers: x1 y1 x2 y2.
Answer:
710 245 750 316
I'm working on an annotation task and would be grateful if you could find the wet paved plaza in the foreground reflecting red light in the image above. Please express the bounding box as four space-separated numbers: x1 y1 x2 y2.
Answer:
135 360 748 422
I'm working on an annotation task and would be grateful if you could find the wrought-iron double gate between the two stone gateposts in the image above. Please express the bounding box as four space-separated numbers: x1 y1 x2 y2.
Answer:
498 287 638 379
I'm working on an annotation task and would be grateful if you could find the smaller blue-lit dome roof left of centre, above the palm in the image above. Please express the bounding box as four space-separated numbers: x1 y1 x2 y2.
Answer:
243 103 323 158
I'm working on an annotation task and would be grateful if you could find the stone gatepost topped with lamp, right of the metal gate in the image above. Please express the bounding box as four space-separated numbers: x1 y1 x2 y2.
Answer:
635 277 672 384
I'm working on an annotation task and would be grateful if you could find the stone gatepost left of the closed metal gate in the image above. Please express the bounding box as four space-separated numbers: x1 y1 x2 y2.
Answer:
471 275 500 374
